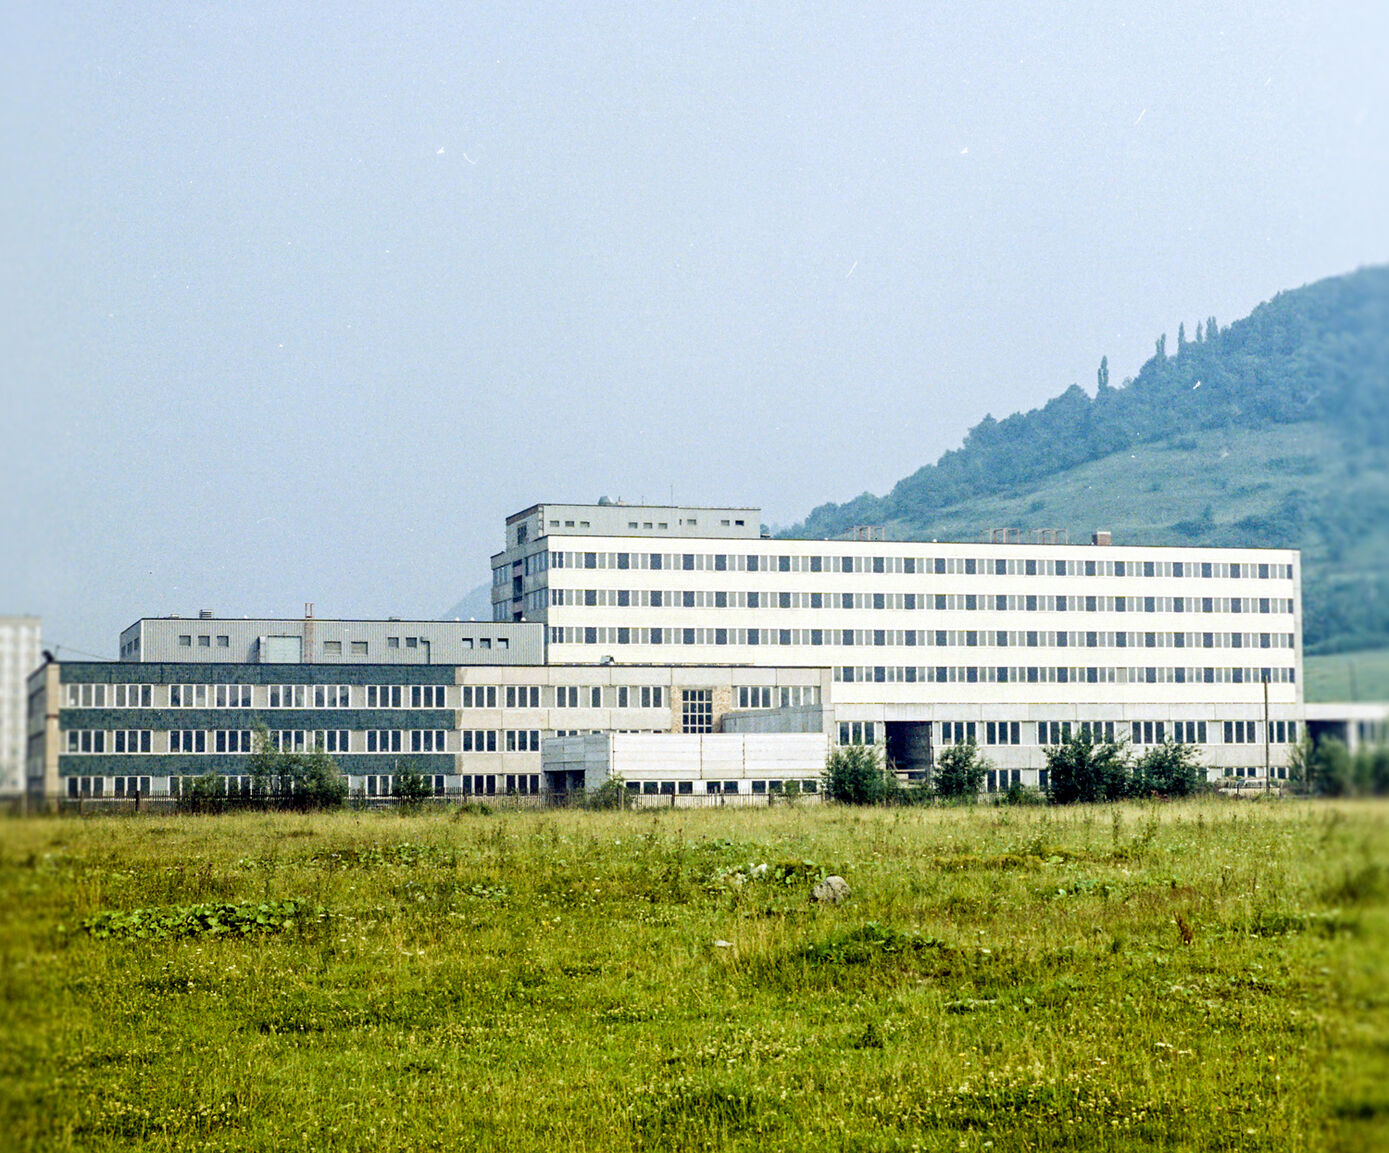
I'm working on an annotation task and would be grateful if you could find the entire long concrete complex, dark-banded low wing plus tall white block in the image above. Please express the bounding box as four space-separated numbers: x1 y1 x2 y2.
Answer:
26 504 1306 800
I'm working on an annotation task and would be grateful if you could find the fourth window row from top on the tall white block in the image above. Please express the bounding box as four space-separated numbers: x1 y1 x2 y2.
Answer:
833 664 1297 685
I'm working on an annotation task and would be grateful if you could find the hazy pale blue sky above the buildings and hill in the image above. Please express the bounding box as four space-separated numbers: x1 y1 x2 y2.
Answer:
0 0 1389 656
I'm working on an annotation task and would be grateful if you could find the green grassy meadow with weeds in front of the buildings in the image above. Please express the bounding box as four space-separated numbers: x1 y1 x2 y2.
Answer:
0 800 1389 1153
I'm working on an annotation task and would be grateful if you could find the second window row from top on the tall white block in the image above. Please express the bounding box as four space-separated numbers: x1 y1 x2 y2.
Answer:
544 589 1293 614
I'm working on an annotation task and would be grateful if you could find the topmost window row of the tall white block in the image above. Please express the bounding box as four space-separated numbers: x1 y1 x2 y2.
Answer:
541 551 1293 585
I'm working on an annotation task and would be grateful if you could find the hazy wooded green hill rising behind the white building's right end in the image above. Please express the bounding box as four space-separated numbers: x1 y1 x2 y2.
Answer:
786 268 1389 652
